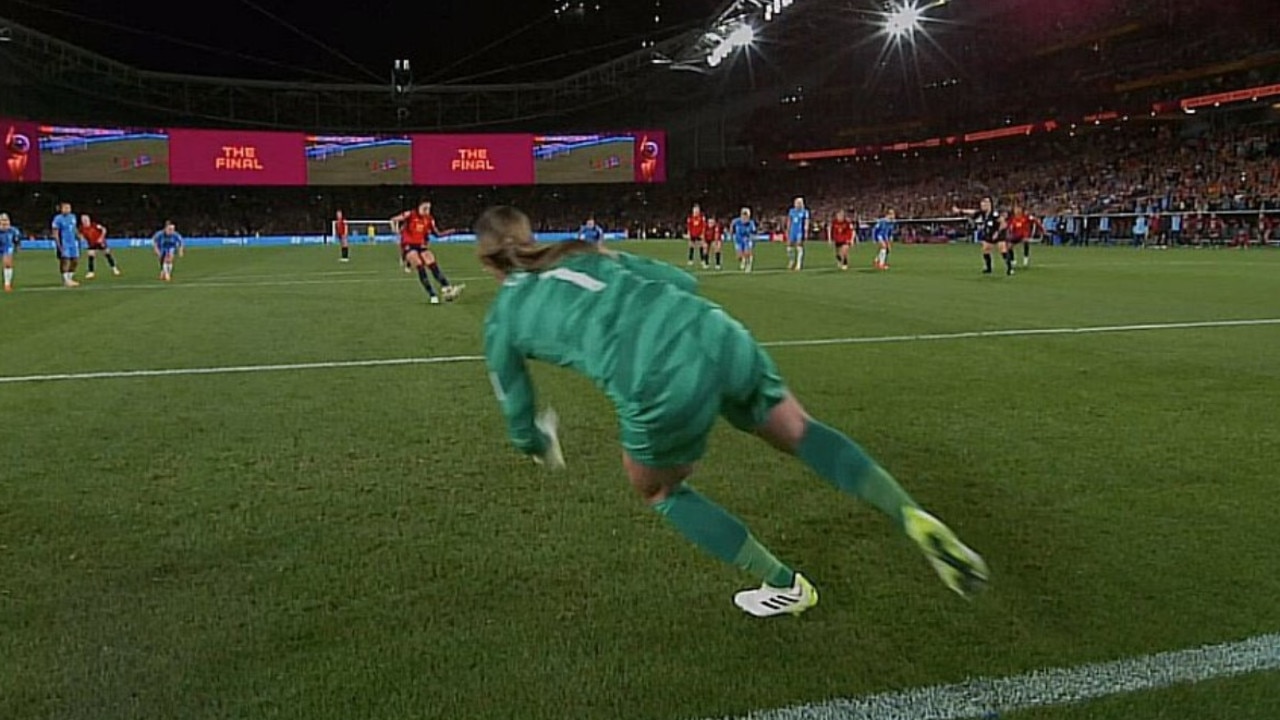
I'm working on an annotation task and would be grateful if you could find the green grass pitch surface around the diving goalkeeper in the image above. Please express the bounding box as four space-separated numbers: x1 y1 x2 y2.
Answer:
0 243 1280 720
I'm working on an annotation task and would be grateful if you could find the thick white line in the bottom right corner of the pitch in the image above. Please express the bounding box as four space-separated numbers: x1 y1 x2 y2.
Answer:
711 633 1280 720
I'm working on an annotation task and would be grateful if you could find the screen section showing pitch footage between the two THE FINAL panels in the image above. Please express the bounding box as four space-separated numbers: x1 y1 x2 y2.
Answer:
307 135 413 184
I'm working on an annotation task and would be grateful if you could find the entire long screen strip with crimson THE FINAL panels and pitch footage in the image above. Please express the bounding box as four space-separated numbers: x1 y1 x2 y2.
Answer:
10 119 667 186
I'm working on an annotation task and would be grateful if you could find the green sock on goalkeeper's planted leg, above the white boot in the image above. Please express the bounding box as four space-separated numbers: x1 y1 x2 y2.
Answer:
653 484 795 588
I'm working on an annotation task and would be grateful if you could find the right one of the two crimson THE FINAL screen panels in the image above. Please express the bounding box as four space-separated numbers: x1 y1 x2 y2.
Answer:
413 135 534 184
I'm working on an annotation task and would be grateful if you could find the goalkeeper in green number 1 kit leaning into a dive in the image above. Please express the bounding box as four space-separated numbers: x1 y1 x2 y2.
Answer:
476 208 988 618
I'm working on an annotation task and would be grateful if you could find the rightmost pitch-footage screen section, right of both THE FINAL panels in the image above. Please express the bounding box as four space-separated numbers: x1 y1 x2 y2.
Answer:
534 133 636 184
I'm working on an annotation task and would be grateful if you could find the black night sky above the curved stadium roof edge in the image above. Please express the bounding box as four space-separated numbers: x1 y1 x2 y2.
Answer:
3 0 719 85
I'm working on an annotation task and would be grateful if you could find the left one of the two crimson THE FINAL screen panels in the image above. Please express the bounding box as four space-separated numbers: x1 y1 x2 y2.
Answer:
169 129 307 184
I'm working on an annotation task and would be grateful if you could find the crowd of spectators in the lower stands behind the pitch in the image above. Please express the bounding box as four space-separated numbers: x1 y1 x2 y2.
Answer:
0 119 1280 243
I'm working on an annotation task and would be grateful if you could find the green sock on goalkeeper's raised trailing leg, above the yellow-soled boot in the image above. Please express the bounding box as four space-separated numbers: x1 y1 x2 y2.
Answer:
796 420 919 527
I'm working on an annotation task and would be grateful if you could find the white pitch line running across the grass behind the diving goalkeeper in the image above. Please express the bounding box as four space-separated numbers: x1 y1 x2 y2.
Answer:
0 318 1280 384
